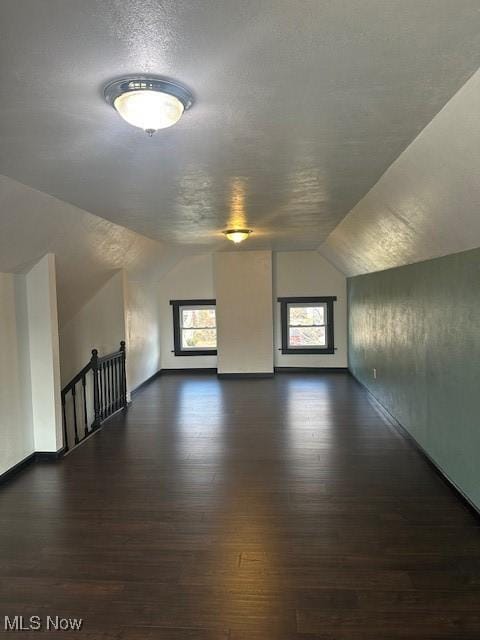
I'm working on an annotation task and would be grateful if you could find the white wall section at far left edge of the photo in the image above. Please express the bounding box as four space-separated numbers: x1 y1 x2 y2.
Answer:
0 273 34 474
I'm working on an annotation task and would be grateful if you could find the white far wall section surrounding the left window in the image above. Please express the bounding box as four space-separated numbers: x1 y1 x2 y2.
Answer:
159 254 217 369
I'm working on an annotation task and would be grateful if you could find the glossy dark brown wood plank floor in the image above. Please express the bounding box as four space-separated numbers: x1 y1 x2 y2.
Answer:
0 374 480 640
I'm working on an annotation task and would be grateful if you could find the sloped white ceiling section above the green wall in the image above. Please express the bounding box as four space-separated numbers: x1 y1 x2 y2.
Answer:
320 71 480 276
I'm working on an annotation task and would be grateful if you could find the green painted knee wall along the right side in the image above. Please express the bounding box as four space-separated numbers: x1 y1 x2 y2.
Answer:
348 249 480 508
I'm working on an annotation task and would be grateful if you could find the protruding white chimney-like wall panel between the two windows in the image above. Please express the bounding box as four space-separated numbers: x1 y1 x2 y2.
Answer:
214 251 273 374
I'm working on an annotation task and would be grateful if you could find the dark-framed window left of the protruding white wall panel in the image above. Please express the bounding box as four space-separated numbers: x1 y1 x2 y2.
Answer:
170 300 217 356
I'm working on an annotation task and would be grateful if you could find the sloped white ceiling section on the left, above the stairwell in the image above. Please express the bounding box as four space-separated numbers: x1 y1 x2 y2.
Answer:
0 176 195 326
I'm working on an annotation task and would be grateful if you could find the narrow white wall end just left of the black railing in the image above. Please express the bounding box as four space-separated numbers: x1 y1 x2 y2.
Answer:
26 254 63 452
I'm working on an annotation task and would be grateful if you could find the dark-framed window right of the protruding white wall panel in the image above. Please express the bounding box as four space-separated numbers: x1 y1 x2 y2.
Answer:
278 297 337 354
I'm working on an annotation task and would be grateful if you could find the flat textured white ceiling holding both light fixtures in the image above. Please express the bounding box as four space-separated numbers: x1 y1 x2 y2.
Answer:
0 0 480 249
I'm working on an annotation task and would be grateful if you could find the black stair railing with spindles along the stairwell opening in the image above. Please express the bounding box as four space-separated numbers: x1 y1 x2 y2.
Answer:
61 340 127 452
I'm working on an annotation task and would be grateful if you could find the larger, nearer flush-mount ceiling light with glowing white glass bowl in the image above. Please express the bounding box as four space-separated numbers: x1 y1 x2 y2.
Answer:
103 76 193 136
